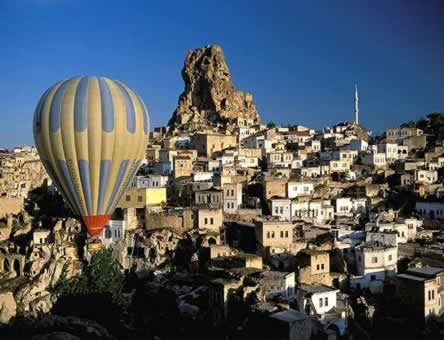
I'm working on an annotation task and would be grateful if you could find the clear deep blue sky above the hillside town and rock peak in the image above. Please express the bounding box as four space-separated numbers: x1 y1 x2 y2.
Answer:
0 0 444 146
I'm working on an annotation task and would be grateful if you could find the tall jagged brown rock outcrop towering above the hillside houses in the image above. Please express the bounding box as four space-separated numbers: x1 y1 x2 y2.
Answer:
168 45 260 133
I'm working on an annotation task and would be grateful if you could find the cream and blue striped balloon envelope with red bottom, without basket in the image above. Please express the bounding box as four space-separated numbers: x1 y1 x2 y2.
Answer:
33 77 150 236
